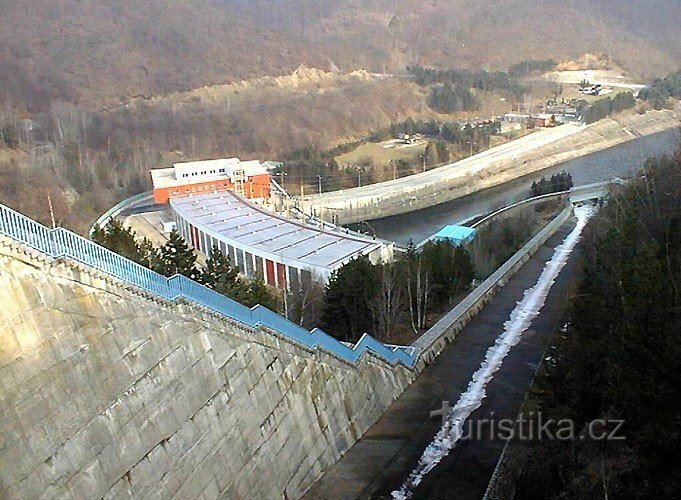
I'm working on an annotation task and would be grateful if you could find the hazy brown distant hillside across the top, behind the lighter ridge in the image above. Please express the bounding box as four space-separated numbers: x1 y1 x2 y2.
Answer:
0 0 681 109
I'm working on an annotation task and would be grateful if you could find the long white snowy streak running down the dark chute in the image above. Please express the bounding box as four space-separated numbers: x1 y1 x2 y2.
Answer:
392 207 594 500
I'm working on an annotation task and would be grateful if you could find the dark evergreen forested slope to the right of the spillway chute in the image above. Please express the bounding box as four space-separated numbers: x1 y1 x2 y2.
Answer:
516 143 681 499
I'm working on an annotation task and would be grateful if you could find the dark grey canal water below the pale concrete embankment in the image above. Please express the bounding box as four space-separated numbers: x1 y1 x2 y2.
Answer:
369 129 679 245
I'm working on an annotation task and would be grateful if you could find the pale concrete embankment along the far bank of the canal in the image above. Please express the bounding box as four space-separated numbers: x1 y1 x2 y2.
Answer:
304 105 681 224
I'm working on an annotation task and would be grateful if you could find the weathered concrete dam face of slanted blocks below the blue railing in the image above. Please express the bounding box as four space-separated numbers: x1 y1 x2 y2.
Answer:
0 236 414 499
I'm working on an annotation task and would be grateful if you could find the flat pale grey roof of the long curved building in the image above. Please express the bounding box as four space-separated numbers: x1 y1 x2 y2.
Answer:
170 191 382 270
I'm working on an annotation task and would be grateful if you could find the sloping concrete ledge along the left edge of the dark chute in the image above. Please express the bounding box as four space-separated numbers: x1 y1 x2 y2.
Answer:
412 205 573 373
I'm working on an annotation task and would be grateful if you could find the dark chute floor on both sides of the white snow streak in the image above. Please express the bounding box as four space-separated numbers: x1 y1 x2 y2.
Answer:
305 221 576 500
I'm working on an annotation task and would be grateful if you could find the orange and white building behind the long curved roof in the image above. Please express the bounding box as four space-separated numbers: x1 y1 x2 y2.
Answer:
151 158 270 203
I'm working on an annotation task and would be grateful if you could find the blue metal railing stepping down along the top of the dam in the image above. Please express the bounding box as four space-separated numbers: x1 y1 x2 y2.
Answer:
0 204 416 368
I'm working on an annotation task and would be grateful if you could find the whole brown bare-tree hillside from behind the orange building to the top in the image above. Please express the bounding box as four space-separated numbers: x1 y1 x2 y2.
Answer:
0 0 681 231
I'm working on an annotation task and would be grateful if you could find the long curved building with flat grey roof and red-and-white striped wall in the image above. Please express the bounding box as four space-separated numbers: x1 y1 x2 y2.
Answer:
170 191 392 289
